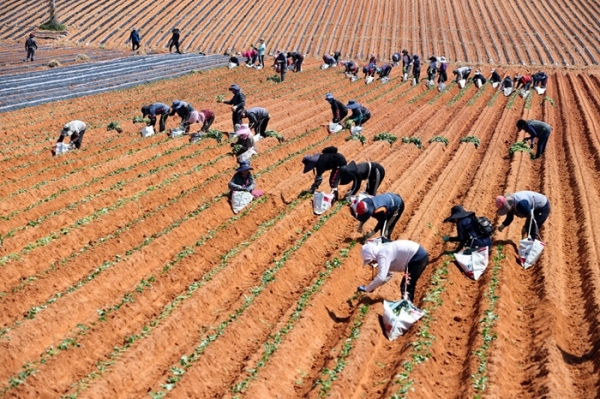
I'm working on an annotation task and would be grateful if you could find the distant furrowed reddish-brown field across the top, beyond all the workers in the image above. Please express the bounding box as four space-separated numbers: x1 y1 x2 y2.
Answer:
0 0 600 66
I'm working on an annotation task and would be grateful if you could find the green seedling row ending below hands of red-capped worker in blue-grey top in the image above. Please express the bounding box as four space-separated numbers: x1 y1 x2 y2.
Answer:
230 241 356 394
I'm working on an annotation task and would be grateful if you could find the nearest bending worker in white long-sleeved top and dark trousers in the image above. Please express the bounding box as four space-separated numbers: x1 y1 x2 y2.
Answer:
357 240 429 302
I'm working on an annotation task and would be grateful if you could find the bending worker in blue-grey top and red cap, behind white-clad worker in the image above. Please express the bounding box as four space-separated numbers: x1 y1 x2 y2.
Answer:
352 193 404 239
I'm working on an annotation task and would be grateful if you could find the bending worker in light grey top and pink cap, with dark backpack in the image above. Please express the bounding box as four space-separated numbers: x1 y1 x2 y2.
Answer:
496 191 550 239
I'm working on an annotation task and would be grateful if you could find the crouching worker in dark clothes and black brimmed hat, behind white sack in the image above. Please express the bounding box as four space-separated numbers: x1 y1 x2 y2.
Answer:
442 205 492 252
